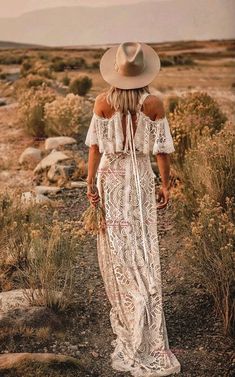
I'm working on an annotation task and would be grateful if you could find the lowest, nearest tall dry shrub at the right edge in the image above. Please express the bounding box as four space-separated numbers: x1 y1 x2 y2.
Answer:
185 194 235 335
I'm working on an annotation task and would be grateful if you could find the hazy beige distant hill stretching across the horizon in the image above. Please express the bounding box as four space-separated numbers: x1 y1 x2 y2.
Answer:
0 0 235 46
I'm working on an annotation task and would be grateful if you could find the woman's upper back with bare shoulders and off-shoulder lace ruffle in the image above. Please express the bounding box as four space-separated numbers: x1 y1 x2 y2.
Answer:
85 92 175 154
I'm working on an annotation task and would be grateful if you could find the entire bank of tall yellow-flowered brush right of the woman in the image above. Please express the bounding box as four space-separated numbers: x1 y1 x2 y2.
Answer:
171 93 235 335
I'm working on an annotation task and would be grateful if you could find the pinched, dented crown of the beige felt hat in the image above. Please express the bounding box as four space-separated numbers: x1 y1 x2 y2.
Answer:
114 42 145 76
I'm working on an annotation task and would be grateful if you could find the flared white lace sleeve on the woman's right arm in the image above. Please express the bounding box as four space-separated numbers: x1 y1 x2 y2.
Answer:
152 116 175 155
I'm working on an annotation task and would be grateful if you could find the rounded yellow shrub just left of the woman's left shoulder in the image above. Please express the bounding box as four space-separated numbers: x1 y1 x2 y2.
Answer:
45 93 90 136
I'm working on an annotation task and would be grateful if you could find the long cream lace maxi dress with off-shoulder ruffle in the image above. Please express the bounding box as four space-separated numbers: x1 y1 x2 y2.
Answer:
85 93 180 377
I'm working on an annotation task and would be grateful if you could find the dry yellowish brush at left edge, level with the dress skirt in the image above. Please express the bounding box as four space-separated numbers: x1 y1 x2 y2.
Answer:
0 192 79 309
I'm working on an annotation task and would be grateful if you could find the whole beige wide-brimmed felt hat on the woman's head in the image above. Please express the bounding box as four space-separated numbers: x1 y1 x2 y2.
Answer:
100 42 161 89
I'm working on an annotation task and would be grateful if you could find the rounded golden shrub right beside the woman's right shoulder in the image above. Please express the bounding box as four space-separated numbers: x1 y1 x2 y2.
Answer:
168 92 227 168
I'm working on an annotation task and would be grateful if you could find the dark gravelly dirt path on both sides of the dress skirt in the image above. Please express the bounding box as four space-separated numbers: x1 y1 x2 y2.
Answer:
35 189 232 377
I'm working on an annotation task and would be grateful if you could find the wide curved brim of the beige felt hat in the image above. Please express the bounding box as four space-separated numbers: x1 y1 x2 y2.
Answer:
100 43 161 89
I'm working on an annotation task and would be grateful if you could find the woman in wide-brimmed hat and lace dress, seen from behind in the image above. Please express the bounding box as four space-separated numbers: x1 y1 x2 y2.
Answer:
85 42 180 377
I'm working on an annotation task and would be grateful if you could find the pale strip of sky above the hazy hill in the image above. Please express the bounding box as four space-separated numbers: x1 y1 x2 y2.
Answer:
0 0 170 17
